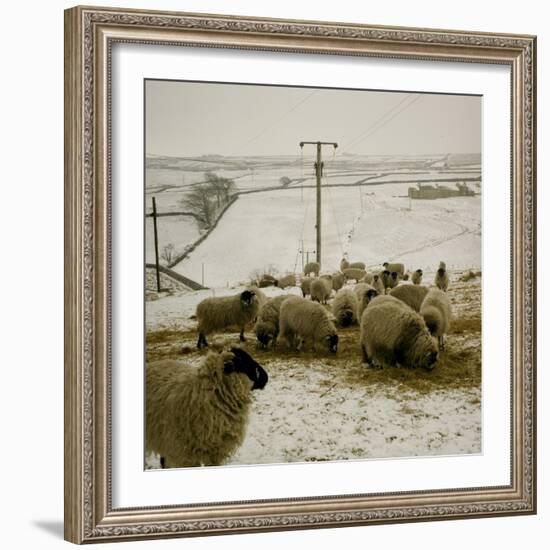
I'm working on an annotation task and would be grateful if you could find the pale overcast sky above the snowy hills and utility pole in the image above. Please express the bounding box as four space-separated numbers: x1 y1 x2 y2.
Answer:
145 80 481 156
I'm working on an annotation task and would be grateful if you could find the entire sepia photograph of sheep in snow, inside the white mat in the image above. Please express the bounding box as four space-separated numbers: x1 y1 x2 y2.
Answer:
144 79 483 469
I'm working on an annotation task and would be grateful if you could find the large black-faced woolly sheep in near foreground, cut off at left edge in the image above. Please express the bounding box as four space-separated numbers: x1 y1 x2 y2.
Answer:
145 348 268 468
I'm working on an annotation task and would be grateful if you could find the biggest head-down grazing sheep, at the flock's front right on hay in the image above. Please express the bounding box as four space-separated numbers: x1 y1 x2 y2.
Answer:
361 296 437 370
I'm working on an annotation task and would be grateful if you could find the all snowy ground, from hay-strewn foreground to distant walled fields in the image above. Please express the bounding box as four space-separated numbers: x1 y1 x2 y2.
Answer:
146 154 482 467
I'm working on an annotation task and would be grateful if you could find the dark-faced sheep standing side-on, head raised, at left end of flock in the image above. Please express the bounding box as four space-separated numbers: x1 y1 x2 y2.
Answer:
196 288 265 349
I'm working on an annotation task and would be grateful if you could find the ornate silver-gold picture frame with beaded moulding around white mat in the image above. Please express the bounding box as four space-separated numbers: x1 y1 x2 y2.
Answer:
64 7 536 543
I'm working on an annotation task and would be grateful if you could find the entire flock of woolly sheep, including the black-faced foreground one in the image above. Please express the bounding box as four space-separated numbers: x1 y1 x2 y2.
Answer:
146 259 452 467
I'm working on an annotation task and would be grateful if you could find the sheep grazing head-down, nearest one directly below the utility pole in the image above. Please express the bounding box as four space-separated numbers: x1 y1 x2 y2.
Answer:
279 296 338 353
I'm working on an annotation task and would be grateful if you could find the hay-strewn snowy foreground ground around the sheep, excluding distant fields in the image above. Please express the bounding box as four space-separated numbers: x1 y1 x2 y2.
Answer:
146 276 482 468
